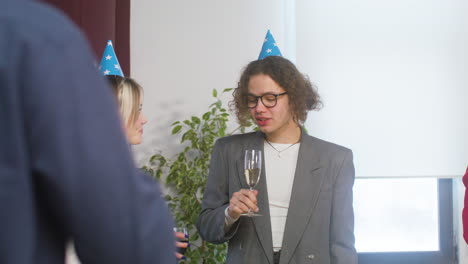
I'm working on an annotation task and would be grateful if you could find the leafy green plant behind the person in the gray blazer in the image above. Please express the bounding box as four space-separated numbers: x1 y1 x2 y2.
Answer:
143 88 252 263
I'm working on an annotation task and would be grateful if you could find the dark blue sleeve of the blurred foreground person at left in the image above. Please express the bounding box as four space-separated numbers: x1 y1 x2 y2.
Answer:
22 23 176 264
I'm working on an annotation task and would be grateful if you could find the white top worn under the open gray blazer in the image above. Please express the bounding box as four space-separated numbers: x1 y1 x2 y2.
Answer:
224 141 300 251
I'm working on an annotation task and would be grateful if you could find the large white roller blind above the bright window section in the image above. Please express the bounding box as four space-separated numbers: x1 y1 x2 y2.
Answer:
296 0 468 177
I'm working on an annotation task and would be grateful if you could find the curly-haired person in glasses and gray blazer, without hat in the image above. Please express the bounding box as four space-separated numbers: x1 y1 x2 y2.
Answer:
197 56 357 264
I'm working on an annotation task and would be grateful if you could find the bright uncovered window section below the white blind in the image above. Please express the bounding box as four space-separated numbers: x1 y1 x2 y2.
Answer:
354 178 455 264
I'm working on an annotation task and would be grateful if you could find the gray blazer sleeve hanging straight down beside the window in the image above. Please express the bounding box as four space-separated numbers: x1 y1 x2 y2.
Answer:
330 150 357 264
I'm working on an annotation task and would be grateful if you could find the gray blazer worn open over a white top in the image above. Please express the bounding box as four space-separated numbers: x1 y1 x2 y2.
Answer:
197 131 357 264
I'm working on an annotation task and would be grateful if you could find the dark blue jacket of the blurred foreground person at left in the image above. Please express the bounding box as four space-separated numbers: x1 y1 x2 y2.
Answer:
0 0 175 264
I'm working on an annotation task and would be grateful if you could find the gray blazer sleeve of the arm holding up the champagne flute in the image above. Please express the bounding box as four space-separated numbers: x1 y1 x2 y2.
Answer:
197 139 239 244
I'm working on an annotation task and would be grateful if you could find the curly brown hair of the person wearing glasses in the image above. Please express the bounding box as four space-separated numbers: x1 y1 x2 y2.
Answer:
229 56 322 126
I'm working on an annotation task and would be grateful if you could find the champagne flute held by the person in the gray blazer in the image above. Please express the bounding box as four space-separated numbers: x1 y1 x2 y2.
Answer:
242 149 262 217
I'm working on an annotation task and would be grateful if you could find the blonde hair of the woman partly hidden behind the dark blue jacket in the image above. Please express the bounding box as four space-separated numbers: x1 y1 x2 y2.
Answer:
106 75 143 126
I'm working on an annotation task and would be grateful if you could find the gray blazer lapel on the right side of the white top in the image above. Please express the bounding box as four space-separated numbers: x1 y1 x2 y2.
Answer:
280 134 323 263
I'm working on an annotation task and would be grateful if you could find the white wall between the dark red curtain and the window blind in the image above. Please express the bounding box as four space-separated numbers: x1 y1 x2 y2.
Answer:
131 0 288 164
